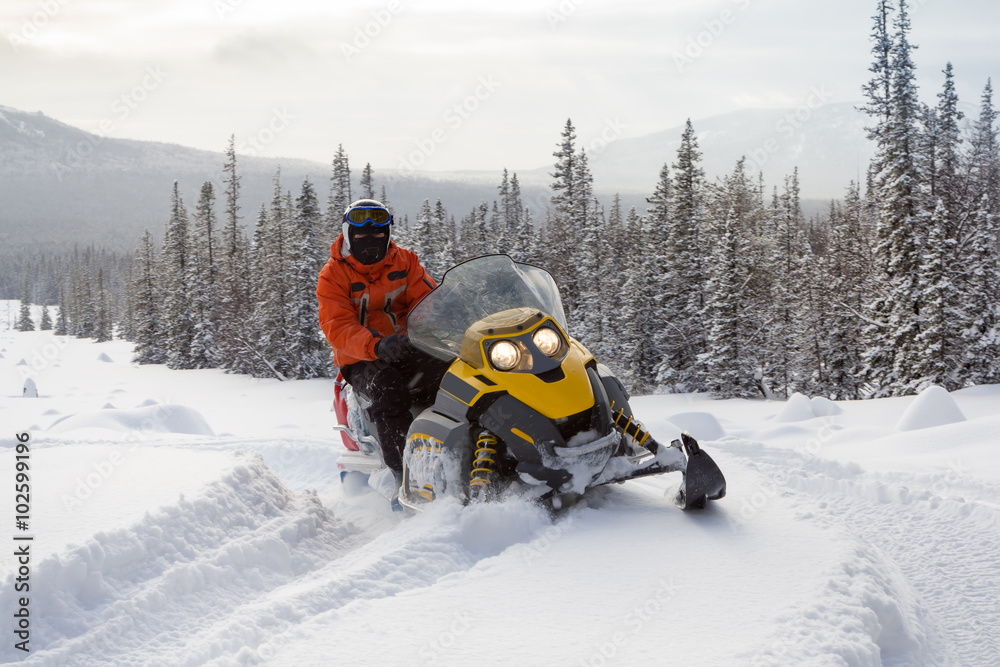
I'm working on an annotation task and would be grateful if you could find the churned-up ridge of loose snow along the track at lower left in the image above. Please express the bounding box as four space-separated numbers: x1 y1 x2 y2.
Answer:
0 456 350 665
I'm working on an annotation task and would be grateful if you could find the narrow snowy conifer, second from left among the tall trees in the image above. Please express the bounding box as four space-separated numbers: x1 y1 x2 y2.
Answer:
161 181 194 369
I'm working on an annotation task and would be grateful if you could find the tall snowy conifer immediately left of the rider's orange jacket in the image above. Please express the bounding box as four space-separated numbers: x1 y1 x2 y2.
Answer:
288 180 331 380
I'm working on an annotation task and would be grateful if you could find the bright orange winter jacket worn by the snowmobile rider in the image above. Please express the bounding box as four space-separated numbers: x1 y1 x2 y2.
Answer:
316 234 437 366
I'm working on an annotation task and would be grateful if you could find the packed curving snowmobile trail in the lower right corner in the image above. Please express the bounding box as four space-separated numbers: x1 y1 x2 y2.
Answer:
725 441 1000 665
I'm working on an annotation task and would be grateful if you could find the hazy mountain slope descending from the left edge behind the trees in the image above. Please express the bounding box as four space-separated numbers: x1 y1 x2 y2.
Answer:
0 106 548 250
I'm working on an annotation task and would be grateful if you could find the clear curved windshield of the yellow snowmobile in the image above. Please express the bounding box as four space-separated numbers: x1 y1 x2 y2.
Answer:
406 255 566 361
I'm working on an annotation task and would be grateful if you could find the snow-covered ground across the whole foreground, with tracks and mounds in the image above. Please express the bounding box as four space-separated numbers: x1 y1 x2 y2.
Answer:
0 304 1000 666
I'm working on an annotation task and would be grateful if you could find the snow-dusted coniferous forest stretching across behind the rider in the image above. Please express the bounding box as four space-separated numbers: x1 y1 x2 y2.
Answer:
5 0 1000 399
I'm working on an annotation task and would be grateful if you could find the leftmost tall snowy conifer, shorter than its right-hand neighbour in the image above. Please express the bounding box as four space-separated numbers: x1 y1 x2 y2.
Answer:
131 229 167 364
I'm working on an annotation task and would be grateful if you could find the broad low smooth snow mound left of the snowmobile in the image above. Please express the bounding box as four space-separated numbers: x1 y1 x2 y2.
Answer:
49 405 215 435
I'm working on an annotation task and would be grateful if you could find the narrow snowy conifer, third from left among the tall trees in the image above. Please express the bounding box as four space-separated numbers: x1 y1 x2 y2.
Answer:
187 181 219 368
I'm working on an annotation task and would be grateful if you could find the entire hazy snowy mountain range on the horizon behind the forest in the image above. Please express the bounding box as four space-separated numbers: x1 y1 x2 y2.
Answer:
0 104 871 249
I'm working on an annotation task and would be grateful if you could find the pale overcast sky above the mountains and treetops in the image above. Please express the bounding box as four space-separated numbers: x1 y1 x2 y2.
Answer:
0 0 1000 170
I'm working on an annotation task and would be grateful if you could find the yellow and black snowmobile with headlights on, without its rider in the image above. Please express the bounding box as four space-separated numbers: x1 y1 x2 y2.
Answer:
334 255 726 511
